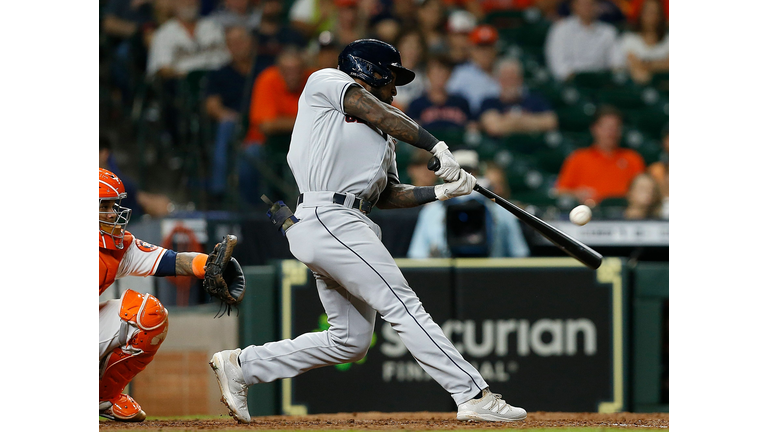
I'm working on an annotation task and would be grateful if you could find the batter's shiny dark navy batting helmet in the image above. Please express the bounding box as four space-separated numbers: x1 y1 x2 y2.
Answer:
339 39 416 87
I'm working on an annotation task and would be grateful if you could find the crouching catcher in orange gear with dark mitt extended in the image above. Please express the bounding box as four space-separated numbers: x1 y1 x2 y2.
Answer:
99 168 245 422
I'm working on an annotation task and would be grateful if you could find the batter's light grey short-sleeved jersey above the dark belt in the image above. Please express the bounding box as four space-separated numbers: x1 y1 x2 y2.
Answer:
288 69 399 202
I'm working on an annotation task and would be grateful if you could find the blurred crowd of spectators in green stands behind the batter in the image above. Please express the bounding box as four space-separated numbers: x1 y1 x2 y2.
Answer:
100 0 669 236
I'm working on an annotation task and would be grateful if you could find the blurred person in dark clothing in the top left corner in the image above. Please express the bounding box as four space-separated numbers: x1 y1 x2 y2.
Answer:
101 0 153 106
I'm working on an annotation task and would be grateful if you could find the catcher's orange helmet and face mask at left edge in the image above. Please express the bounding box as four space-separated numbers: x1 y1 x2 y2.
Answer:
99 168 131 250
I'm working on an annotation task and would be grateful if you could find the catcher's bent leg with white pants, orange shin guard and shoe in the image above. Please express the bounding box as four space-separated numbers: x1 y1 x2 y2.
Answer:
99 290 168 421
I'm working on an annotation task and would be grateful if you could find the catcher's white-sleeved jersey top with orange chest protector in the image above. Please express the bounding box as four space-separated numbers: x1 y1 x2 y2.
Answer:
99 231 166 295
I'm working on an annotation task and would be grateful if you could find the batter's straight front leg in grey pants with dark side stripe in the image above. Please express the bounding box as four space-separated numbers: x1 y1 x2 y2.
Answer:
313 208 488 405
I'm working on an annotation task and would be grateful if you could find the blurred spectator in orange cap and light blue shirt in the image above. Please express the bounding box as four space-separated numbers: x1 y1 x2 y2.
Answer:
447 24 501 115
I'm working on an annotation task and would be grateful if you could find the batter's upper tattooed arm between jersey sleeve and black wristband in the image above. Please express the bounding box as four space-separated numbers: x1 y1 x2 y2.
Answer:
344 86 421 145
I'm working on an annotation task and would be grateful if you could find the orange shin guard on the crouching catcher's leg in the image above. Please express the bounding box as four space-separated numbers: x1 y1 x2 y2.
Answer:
99 290 168 402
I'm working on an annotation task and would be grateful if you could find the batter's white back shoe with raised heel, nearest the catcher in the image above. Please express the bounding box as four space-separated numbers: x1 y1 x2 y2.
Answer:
208 348 251 423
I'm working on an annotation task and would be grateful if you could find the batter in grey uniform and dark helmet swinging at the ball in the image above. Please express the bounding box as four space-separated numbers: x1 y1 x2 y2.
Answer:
210 39 526 423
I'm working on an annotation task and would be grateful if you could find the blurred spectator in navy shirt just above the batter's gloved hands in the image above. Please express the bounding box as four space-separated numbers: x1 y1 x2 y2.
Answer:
407 57 477 139
